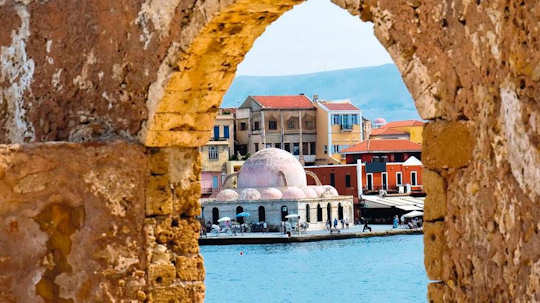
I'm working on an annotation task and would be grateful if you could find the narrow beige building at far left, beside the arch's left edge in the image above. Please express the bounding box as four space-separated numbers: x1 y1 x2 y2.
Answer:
199 108 235 197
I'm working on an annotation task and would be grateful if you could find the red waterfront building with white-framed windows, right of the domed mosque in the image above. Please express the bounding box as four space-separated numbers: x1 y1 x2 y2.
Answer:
306 140 425 222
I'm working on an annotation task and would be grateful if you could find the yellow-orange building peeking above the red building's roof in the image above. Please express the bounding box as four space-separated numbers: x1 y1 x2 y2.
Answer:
370 120 424 144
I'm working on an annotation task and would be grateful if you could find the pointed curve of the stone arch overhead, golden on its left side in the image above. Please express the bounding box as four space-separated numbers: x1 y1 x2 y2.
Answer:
141 0 448 146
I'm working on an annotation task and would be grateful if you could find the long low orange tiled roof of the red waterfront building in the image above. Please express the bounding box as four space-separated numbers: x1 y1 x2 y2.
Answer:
342 139 422 154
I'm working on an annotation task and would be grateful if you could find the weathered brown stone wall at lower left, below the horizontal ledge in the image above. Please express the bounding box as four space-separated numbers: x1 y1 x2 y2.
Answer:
0 142 204 302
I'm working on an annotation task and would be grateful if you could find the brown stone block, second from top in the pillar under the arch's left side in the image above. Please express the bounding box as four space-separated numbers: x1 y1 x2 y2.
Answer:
146 175 173 216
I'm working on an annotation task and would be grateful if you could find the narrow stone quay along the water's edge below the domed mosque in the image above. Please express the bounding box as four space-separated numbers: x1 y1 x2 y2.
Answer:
199 225 422 245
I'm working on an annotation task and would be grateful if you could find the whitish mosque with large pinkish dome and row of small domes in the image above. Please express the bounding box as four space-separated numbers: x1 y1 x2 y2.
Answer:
201 148 353 230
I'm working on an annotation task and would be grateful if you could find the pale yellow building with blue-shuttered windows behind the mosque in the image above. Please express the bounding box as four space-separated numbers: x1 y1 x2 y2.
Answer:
314 97 364 165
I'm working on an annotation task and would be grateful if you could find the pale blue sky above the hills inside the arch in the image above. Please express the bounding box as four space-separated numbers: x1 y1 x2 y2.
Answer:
237 0 392 76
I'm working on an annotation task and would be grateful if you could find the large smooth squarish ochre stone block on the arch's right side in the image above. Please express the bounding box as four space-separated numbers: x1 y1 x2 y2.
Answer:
422 121 475 169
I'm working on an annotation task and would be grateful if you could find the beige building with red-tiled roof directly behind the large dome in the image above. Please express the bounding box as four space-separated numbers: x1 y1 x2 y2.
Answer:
236 95 317 165
